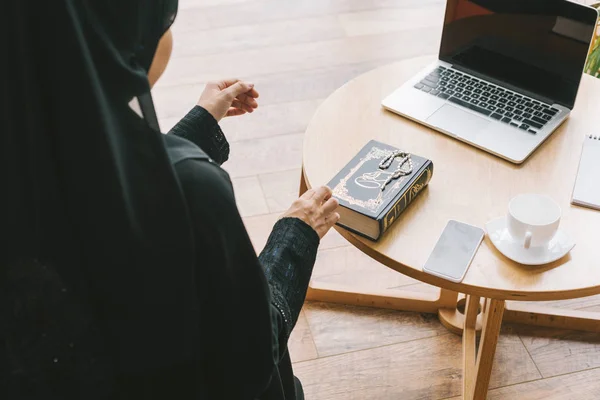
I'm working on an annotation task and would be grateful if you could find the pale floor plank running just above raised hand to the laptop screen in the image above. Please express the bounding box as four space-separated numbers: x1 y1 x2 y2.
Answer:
157 28 440 89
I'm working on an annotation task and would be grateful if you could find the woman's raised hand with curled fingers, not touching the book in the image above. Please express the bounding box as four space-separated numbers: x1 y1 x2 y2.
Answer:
198 79 258 122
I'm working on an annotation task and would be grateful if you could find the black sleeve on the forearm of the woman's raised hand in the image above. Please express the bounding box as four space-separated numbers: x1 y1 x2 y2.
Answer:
168 106 229 165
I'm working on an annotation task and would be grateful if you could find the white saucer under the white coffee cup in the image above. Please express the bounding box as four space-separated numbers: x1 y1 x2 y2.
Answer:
485 217 575 265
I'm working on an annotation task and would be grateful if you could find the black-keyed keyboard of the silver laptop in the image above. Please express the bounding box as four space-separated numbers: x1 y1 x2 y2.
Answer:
415 66 559 134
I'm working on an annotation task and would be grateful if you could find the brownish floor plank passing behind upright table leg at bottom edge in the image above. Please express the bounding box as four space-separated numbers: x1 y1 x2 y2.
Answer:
294 331 540 400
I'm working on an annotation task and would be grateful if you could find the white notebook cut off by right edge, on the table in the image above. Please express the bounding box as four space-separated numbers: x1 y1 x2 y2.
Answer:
571 135 600 210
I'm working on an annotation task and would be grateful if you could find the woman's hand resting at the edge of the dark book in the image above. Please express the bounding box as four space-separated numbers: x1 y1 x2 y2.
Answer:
281 186 340 239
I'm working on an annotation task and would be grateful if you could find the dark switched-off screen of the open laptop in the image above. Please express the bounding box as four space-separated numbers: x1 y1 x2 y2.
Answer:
440 0 597 108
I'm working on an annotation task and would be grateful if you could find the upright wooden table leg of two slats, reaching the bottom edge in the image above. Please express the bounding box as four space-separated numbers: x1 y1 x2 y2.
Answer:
463 296 504 400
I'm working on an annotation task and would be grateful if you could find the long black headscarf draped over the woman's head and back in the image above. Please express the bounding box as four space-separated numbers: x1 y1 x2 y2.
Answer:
0 0 199 373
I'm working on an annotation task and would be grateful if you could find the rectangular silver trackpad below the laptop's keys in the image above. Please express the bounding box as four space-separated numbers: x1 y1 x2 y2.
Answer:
427 104 491 140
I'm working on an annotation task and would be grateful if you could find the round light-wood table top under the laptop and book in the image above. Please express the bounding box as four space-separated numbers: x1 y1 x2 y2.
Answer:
303 57 600 300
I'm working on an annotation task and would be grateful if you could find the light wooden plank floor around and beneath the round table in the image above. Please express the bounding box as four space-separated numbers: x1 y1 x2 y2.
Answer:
154 0 600 400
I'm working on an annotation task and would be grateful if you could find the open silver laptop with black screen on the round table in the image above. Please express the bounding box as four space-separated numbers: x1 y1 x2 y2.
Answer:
382 0 598 164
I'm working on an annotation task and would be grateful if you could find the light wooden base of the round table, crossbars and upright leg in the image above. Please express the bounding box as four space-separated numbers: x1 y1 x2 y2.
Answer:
300 174 600 400
